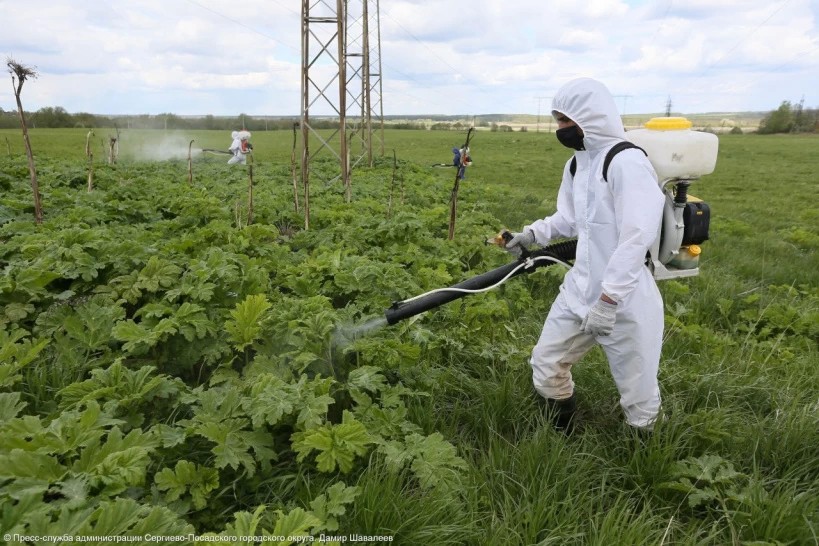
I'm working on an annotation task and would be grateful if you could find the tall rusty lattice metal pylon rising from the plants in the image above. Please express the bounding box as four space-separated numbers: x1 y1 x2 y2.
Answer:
301 0 384 200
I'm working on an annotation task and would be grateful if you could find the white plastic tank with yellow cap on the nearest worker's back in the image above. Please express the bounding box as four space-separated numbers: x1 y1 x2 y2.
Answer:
626 117 719 182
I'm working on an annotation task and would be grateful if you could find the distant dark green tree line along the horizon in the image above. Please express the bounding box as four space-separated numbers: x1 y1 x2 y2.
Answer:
0 101 819 134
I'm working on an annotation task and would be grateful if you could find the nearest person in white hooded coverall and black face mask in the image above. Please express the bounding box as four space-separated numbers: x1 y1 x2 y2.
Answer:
507 78 663 432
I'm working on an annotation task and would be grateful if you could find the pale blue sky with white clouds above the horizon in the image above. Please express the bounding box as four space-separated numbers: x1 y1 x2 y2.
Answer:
0 0 819 116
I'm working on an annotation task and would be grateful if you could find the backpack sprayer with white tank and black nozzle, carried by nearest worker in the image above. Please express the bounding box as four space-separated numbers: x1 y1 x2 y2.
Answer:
384 117 718 324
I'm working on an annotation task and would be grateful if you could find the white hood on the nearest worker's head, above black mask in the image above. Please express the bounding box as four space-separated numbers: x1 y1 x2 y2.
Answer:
552 78 626 151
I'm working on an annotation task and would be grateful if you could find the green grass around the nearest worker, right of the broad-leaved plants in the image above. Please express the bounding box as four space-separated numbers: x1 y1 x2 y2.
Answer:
388 133 819 544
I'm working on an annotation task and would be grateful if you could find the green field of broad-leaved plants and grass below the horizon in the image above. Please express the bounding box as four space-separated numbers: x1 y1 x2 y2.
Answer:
0 125 819 545
